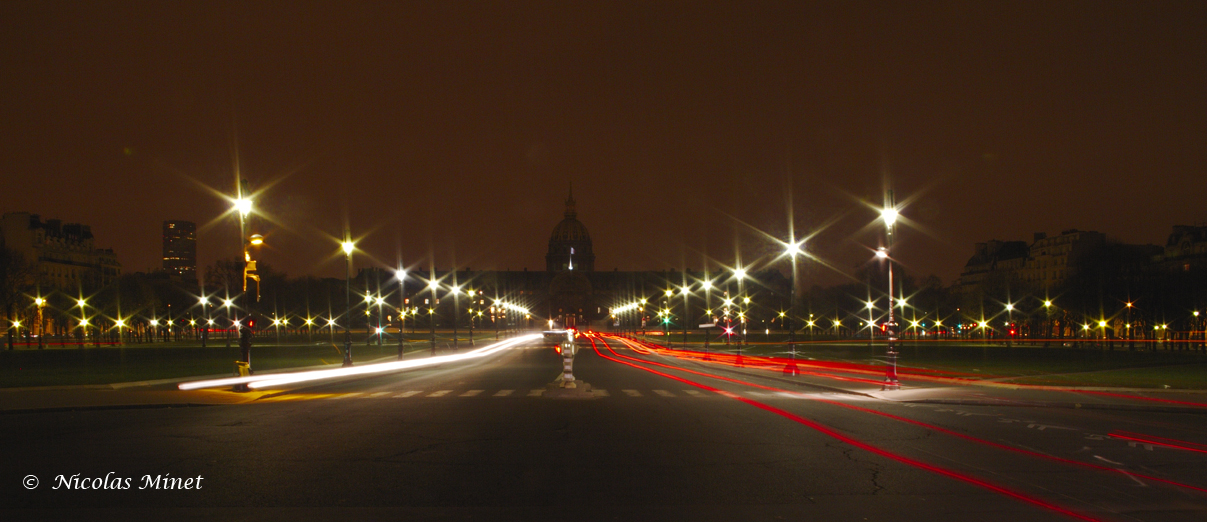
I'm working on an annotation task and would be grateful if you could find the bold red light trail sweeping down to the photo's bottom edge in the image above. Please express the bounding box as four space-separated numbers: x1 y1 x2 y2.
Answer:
591 340 1097 521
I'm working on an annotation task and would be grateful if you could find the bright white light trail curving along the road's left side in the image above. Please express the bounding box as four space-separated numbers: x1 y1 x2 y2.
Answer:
177 334 541 390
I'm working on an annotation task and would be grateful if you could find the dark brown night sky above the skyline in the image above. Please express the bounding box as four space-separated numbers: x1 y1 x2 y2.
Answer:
0 1 1207 283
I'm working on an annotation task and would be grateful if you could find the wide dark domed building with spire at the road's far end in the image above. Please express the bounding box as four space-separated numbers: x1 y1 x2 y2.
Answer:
352 189 791 331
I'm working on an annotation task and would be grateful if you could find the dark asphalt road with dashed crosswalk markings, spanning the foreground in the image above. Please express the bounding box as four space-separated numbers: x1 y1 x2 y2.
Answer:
0 340 1207 521
